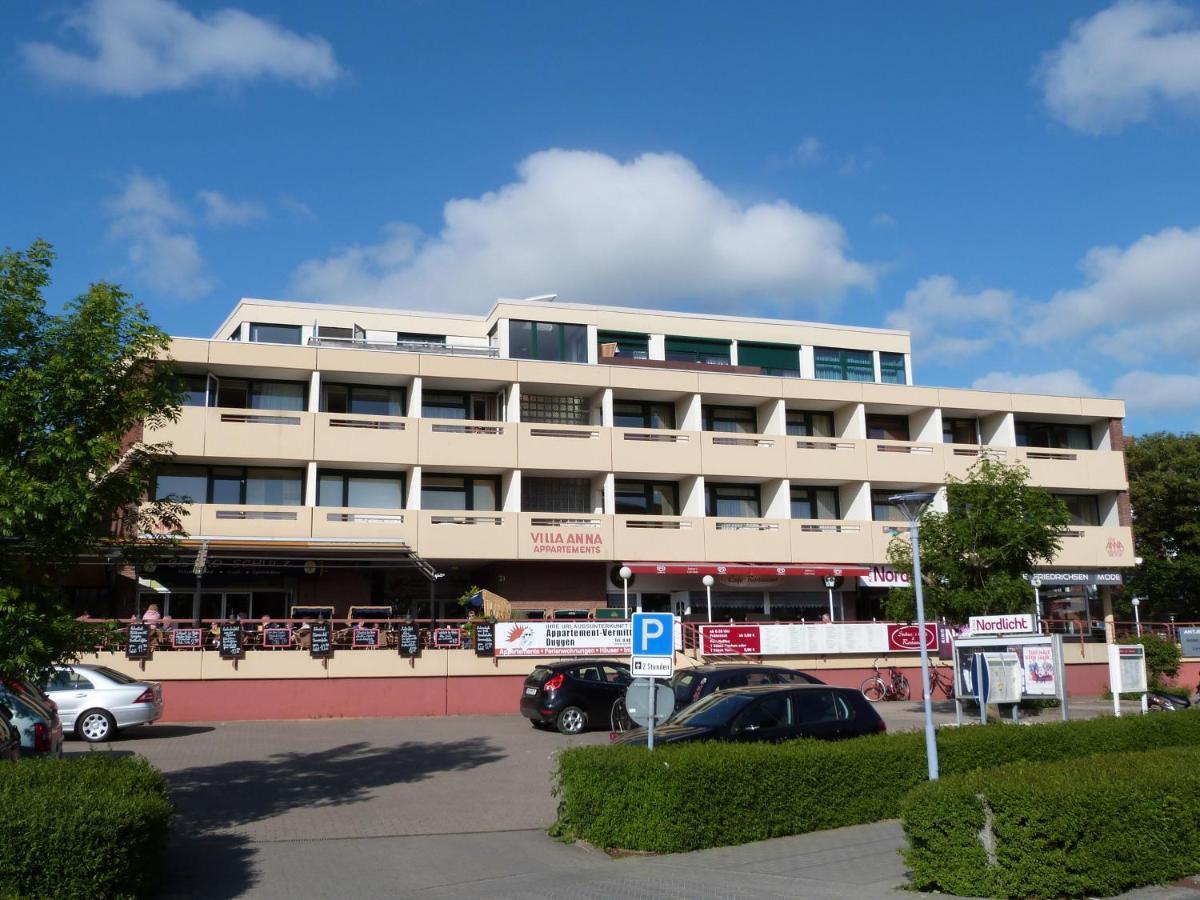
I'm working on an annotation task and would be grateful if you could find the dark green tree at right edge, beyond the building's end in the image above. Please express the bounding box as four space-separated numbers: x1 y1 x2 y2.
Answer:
1126 432 1200 619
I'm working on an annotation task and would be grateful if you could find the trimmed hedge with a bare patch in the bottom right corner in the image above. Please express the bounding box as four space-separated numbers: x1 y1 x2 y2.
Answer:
901 748 1200 898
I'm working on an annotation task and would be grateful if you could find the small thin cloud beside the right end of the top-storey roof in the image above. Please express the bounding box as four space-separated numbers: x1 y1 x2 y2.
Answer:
887 275 1019 359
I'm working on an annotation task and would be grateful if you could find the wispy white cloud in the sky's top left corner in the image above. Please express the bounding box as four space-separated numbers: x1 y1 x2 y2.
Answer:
20 0 342 97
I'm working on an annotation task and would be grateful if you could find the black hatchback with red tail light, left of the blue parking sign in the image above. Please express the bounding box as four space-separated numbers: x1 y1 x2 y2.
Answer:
521 659 632 734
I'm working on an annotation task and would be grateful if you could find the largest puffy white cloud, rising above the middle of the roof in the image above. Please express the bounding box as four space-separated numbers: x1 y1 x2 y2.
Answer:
293 150 875 311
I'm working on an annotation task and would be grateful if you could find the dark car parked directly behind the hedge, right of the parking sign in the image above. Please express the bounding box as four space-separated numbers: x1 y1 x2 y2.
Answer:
614 684 887 744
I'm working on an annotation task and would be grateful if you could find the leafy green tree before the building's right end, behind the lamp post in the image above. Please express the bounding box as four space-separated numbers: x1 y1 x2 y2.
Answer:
887 457 1070 622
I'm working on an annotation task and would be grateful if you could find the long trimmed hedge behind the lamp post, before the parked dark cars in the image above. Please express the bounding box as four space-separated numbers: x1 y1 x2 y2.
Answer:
554 709 1200 852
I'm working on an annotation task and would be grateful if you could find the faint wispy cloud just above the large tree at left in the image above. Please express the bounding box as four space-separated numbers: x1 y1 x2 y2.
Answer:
103 172 214 300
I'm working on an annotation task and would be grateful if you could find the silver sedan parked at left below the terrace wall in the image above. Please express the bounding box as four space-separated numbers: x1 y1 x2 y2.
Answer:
46 662 162 744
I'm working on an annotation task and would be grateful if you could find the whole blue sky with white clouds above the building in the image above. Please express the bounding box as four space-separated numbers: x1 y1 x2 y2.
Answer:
0 0 1200 433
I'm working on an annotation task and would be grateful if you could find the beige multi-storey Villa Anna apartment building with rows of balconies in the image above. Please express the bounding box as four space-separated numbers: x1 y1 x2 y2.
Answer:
77 300 1134 620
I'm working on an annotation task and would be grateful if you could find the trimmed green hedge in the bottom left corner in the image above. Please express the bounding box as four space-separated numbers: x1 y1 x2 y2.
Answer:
0 752 172 898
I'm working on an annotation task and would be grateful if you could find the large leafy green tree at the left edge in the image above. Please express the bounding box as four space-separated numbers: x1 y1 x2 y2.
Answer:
0 241 180 677
